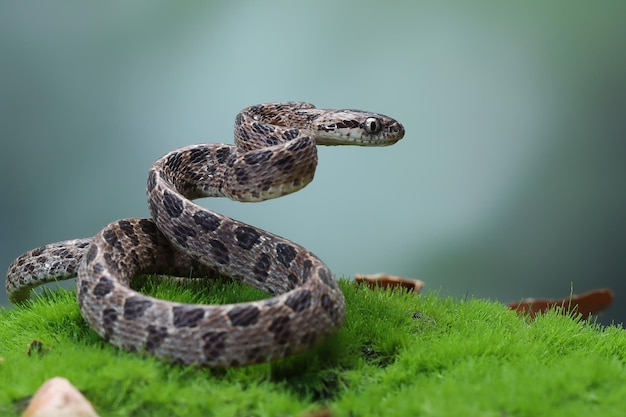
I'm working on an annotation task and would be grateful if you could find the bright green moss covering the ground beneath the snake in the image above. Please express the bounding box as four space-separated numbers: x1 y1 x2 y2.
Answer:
0 281 626 417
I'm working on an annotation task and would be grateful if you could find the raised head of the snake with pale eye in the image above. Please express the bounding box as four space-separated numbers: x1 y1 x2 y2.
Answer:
311 109 404 146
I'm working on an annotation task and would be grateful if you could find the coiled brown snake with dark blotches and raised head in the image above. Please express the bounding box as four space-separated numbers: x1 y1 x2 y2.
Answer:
5 102 404 368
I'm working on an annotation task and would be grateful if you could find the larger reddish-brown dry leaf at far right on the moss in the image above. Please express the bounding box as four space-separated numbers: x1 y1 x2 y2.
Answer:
508 288 613 319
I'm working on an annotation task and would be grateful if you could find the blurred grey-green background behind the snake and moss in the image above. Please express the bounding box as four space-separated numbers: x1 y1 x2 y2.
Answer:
0 0 626 322
